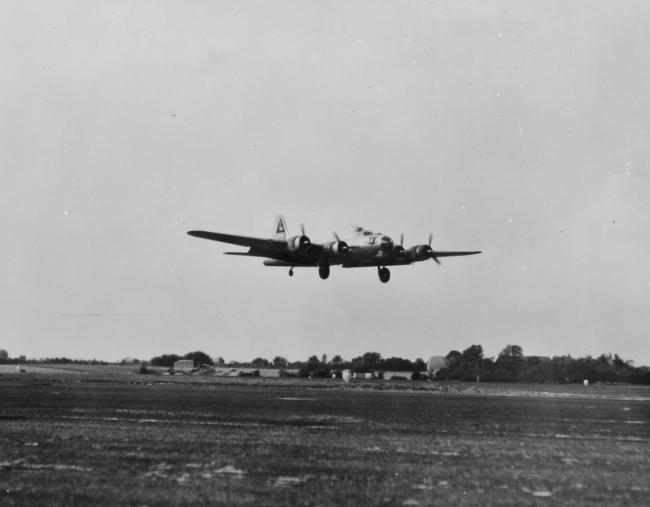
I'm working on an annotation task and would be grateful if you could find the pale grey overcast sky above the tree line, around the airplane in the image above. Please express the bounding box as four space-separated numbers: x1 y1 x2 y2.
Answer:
0 0 650 365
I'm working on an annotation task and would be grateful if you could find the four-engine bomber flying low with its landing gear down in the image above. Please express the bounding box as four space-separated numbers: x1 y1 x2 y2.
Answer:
188 215 481 283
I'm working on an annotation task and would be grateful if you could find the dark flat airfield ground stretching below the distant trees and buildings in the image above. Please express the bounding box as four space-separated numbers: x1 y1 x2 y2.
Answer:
0 372 650 506
